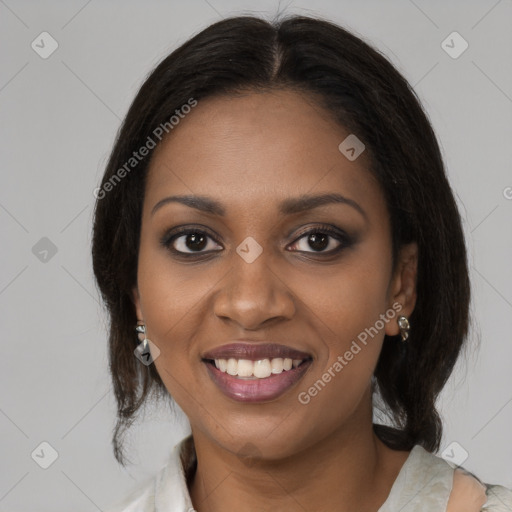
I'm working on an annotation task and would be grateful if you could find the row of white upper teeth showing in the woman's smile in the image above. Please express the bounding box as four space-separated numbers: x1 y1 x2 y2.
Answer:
214 357 302 379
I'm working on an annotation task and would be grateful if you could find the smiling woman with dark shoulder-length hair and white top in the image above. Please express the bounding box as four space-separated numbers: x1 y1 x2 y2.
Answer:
92 17 512 512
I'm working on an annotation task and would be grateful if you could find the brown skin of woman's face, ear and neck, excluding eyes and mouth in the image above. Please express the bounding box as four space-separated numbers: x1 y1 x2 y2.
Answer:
133 90 417 512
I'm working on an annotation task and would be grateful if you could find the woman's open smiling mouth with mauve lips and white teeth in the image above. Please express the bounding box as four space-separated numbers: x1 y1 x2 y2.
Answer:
201 343 313 402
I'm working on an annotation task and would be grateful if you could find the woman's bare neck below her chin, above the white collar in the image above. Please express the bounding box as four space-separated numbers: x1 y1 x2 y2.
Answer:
190 400 408 512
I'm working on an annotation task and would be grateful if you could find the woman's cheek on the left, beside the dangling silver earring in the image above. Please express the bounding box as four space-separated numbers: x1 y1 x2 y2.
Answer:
138 239 232 408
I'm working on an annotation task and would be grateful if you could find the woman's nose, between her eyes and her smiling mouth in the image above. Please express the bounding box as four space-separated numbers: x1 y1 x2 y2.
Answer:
214 247 295 330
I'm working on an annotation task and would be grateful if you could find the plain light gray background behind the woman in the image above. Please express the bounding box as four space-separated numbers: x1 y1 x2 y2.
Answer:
0 0 512 511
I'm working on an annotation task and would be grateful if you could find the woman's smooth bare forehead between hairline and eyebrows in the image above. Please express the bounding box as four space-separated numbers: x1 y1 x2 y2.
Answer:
145 90 384 220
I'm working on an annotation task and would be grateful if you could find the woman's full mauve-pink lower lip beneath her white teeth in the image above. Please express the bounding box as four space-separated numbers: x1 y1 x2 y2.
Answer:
204 360 311 402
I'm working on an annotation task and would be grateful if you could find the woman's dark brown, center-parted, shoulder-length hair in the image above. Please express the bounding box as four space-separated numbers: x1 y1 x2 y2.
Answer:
92 16 470 464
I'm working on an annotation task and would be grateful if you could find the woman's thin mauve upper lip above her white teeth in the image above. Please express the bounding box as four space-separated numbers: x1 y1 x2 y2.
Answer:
202 342 311 361
